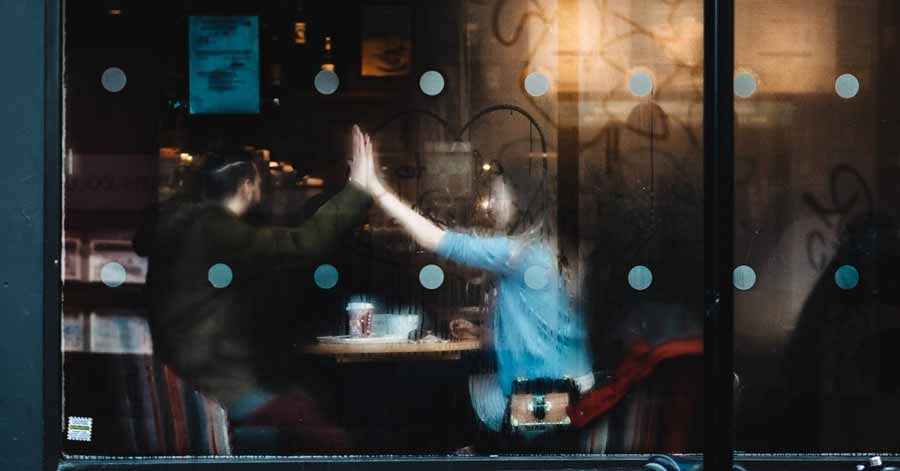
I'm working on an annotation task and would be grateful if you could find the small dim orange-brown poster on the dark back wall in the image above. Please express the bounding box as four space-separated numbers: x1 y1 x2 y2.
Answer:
362 5 412 77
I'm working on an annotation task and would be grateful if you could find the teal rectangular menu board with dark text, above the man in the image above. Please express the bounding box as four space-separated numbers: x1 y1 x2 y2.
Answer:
189 16 259 114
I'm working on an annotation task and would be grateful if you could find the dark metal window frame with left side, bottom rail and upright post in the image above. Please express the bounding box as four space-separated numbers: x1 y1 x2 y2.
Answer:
0 0 888 471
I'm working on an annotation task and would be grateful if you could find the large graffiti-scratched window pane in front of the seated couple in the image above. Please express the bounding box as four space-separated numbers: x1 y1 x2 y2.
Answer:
61 0 704 459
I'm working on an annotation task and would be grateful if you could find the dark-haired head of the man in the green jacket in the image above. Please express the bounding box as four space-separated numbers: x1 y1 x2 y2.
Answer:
203 152 262 215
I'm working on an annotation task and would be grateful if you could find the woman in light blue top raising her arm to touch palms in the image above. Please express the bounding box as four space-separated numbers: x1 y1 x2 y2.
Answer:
356 128 593 438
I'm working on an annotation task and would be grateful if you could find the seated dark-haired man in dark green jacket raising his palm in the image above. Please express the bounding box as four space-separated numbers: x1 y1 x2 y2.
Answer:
135 126 371 453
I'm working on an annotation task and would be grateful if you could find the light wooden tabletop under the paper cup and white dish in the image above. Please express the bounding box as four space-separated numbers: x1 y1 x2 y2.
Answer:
300 340 481 363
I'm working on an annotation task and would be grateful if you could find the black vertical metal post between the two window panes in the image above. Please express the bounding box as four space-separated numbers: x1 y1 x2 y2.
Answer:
703 0 734 470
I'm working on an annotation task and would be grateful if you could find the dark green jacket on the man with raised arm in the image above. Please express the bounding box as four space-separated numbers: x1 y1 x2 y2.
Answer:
135 185 371 405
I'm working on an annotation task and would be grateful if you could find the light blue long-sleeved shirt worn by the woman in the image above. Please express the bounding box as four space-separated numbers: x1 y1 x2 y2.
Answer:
437 232 592 397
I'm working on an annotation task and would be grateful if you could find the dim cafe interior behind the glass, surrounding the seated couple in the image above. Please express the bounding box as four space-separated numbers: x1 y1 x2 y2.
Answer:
62 0 900 456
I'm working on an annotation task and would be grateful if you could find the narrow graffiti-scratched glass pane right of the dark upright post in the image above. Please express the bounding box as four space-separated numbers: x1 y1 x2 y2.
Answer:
734 0 900 453
